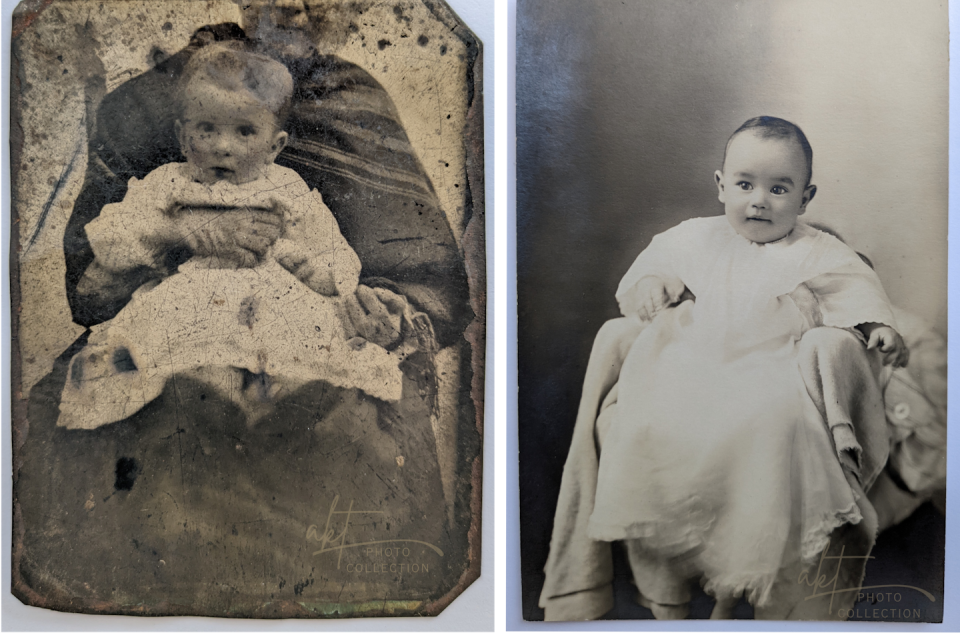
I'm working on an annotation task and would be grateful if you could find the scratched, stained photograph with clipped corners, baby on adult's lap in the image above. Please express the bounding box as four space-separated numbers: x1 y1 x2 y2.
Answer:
11 0 486 618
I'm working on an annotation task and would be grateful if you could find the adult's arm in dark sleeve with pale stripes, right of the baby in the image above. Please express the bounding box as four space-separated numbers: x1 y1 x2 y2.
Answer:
277 56 473 346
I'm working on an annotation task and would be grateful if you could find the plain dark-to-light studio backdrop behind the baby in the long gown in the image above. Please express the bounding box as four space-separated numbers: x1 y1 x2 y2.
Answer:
508 0 953 617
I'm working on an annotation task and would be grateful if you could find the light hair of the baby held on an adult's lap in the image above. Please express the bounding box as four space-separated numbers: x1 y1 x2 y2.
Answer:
179 40 293 128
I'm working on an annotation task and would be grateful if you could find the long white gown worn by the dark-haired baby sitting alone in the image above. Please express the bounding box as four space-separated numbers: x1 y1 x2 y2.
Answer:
588 216 896 604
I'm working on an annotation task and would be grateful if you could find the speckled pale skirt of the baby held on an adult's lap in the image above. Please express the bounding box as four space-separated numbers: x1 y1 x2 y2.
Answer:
58 259 402 429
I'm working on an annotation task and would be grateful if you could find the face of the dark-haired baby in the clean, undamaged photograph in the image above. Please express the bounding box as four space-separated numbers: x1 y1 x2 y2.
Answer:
714 131 816 244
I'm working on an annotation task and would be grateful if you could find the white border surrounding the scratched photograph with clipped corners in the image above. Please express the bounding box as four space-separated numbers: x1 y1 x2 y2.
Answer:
0 0 497 633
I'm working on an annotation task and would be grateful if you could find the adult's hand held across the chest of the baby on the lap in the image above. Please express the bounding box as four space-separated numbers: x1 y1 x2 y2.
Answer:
179 208 283 268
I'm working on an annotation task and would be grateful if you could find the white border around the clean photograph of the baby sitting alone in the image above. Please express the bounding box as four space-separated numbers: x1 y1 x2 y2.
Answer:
504 0 960 633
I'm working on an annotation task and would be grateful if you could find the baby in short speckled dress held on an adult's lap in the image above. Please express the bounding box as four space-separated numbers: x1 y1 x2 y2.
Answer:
59 42 400 428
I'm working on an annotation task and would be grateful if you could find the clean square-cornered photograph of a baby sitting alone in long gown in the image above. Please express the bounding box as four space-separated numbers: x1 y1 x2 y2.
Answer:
516 0 948 622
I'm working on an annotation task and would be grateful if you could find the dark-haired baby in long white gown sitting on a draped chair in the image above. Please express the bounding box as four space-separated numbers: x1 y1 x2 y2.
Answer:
547 117 908 618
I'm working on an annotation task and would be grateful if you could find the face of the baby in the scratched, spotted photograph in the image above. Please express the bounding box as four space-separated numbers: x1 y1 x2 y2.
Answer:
177 82 287 185
